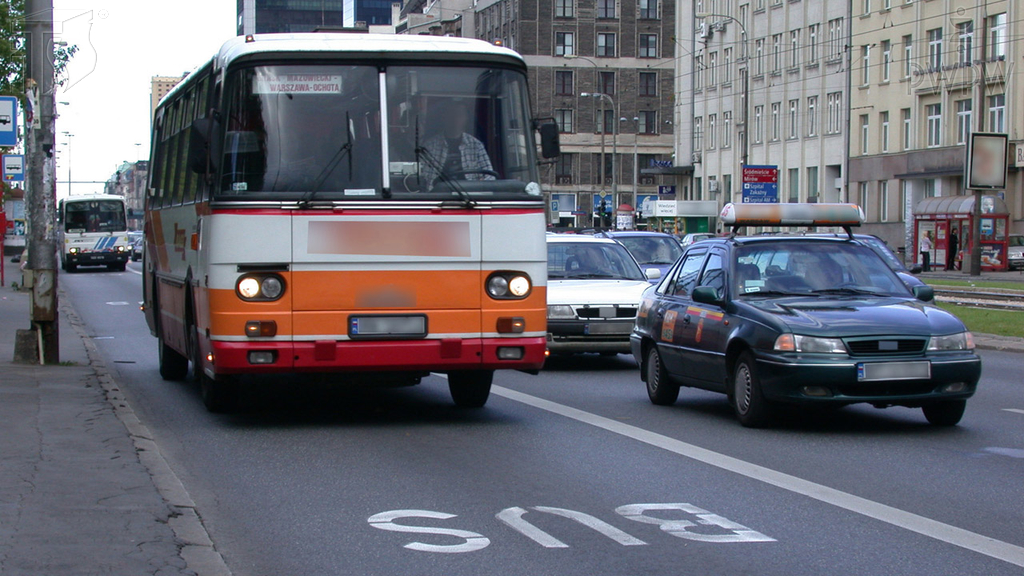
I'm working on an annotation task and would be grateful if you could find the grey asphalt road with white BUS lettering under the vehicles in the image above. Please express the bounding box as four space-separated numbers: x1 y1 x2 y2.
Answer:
60 263 1024 576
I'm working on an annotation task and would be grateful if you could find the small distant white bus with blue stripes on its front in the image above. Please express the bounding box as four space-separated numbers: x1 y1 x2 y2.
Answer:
57 194 131 272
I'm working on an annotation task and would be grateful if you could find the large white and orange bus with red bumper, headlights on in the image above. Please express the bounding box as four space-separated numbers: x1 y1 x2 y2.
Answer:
142 33 558 411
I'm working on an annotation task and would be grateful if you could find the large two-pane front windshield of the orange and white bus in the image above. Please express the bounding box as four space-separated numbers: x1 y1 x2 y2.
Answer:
220 65 540 200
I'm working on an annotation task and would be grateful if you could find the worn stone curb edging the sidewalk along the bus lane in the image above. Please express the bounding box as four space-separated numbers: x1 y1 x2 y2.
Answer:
58 289 231 576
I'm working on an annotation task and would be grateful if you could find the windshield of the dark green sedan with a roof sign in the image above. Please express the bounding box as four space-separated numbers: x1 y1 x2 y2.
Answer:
733 241 910 297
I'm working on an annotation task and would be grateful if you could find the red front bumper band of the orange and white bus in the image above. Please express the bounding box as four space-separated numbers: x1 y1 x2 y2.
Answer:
205 337 547 374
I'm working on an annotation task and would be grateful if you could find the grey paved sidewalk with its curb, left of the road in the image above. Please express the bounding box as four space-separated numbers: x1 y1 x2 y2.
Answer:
0 256 229 576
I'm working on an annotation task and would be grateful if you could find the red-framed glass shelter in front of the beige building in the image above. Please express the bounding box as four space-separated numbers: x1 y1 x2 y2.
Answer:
913 195 1010 271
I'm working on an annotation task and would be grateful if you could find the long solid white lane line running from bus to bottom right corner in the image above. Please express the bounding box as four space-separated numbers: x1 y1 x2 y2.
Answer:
490 386 1024 567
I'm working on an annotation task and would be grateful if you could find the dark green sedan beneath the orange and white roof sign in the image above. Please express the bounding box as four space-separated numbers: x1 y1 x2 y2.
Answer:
630 229 981 426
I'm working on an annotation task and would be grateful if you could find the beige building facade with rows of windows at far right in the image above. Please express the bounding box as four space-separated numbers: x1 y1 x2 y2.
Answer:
850 0 1024 252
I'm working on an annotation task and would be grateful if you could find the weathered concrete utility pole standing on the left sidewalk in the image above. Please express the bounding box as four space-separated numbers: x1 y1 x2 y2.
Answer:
19 0 60 364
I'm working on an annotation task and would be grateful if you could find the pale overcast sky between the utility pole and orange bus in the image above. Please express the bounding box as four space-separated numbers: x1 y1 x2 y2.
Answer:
53 0 238 198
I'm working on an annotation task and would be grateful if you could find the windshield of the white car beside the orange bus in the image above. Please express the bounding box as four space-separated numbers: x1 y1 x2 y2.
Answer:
548 242 646 280
